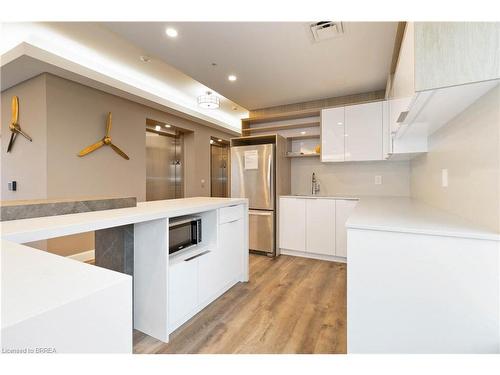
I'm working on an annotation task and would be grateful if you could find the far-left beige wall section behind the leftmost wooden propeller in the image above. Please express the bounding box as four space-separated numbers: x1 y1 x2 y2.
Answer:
0 76 47 200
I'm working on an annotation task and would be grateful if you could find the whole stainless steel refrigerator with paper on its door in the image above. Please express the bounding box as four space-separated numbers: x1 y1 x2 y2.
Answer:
231 144 276 256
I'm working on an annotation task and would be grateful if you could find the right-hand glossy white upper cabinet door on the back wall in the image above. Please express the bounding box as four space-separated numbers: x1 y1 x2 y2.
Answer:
345 102 383 161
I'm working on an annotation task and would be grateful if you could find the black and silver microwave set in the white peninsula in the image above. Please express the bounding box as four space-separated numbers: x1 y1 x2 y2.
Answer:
168 217 201 254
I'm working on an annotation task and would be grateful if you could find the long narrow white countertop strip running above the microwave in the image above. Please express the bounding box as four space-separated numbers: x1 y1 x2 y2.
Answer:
0 197 248 243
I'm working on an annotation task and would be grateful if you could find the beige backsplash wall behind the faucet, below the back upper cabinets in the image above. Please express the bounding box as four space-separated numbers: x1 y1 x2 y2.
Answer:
292 158 410 196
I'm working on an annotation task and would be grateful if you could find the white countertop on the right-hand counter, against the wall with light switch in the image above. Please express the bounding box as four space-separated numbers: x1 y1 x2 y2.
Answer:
346 197 500 241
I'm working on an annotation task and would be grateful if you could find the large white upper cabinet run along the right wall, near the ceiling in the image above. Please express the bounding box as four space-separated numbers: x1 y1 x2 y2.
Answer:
389 22 500 148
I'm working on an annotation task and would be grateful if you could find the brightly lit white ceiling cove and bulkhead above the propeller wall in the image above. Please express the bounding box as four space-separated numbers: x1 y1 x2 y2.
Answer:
0 22 248 132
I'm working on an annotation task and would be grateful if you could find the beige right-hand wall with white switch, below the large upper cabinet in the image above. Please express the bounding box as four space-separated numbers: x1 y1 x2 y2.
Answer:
411 87 500 232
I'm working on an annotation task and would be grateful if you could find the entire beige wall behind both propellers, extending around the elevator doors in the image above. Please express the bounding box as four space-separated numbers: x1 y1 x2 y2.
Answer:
2 74 236 255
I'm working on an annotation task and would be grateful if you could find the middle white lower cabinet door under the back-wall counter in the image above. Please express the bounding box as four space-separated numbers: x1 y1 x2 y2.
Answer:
306 199 335 255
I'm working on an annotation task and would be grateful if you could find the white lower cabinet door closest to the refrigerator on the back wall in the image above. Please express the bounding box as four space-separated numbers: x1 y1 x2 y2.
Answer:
279 198 306 251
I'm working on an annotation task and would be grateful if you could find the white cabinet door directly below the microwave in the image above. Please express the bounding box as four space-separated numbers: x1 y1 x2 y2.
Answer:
168 258 198 330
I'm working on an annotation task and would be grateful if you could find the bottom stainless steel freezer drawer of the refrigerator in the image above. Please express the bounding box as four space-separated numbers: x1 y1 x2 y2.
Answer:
248 210 274 253
